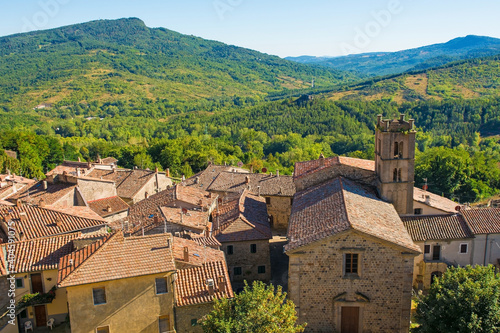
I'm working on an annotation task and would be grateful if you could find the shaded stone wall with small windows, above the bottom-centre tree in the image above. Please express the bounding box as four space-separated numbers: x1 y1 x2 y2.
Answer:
222 240 271 290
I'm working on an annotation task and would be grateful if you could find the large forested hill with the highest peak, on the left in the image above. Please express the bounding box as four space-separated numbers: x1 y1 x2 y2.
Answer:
0 18 355 113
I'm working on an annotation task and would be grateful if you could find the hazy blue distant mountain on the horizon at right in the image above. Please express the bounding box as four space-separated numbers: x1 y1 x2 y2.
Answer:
285 35 500 76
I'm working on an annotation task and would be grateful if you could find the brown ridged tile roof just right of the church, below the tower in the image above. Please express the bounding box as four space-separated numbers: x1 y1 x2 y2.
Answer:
401 214 474 242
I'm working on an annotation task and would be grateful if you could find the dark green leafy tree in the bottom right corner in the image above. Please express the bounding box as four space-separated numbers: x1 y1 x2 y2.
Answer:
414 265 500 333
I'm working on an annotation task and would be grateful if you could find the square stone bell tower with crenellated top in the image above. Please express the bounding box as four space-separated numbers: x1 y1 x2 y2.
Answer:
375 114 415 215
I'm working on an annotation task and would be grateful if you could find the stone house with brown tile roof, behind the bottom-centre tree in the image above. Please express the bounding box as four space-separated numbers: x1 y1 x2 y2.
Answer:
212 190 272 289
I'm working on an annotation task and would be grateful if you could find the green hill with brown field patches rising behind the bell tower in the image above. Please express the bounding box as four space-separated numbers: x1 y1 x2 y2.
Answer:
318 56 500 103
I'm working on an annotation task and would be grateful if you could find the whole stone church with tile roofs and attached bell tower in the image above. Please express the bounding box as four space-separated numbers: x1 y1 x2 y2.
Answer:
285 115 422 333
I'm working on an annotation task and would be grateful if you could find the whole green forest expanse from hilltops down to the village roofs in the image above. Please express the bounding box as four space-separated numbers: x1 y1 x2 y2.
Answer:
0 19 500 202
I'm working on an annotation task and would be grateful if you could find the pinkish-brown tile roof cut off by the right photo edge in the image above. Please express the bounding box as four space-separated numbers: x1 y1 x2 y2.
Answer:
461 208 500 235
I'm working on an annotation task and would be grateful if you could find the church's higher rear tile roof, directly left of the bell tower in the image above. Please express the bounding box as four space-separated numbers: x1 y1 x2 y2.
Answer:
293 156 375 178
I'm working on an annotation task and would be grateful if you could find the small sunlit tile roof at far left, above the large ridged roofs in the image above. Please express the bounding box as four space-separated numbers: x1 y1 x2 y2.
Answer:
7 181 76 205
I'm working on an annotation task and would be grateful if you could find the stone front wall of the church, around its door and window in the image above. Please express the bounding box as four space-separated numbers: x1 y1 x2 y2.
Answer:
287 231 414 333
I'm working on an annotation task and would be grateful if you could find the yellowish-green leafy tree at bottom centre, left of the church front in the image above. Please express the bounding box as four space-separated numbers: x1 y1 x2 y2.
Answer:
202 281 306 333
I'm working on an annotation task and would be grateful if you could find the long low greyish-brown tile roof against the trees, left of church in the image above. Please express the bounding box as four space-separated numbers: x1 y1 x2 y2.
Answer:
208 172 295 197
